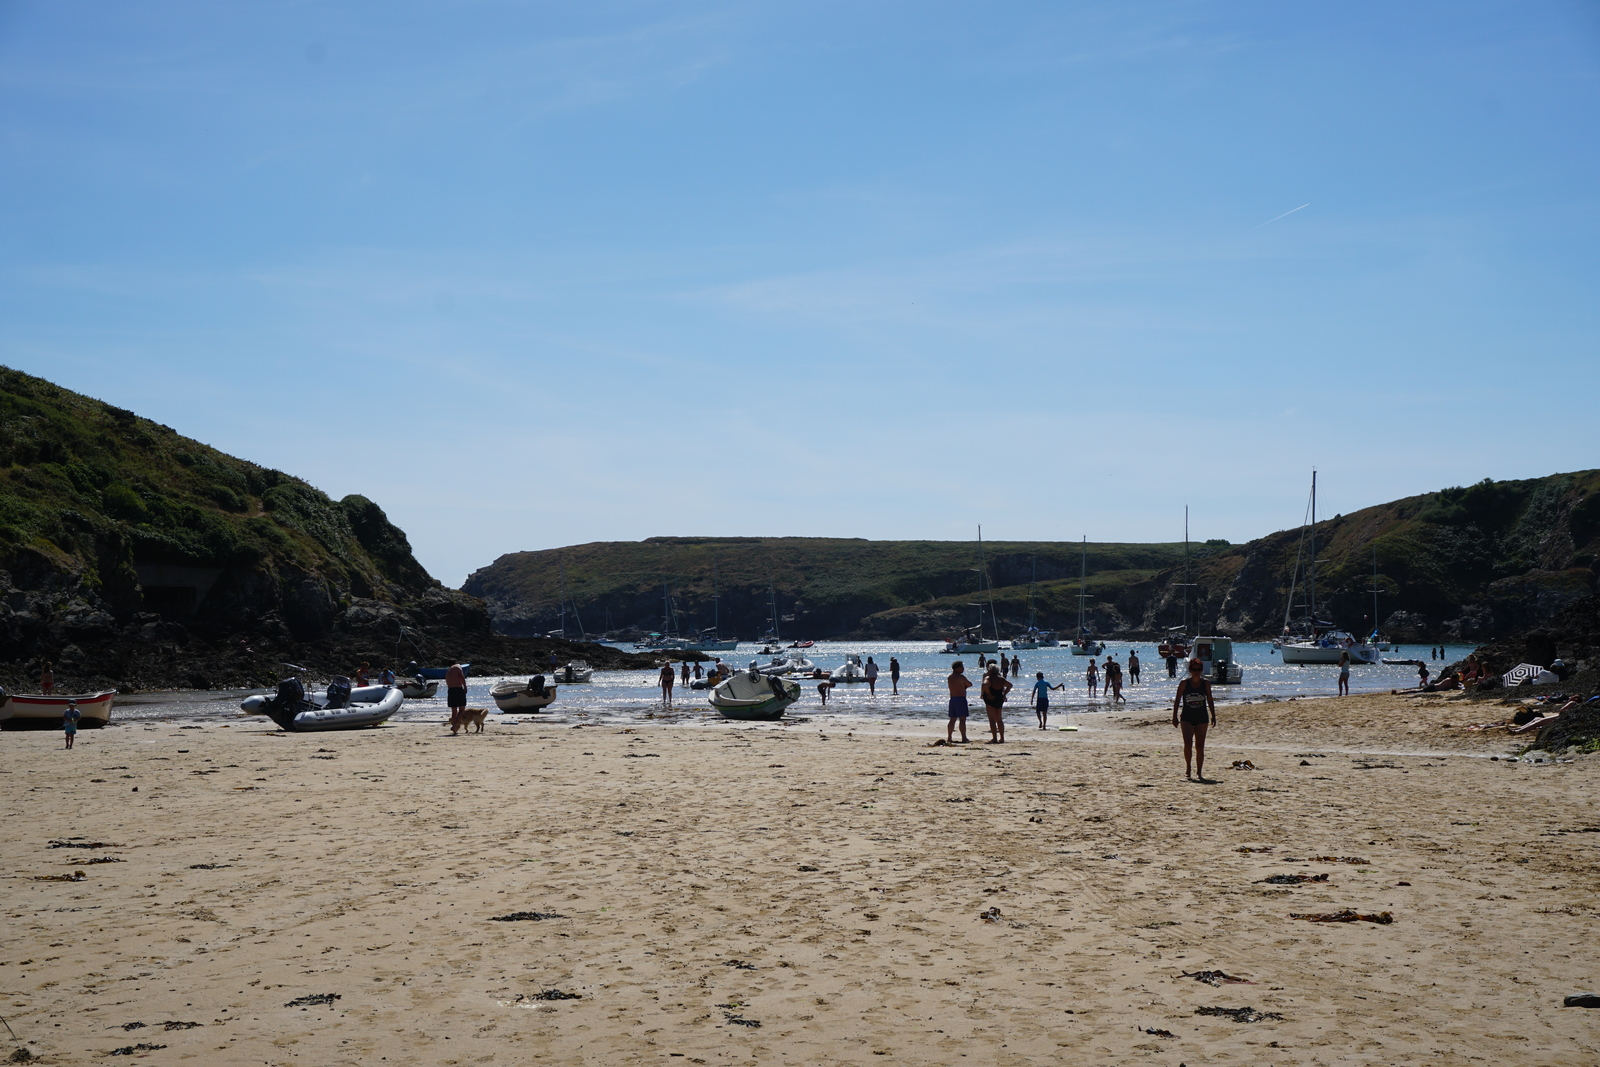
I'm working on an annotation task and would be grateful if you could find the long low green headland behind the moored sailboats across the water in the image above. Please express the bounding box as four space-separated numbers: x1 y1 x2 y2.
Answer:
462 470 1600 641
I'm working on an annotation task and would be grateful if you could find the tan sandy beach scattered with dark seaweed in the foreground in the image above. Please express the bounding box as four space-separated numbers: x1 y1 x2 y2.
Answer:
0 696 1600 1067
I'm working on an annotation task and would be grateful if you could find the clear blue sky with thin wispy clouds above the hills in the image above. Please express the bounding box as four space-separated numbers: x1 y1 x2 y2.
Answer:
0 0 1600 585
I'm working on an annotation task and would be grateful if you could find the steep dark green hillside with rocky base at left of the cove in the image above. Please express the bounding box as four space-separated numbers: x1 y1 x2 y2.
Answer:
0 368 649 689
